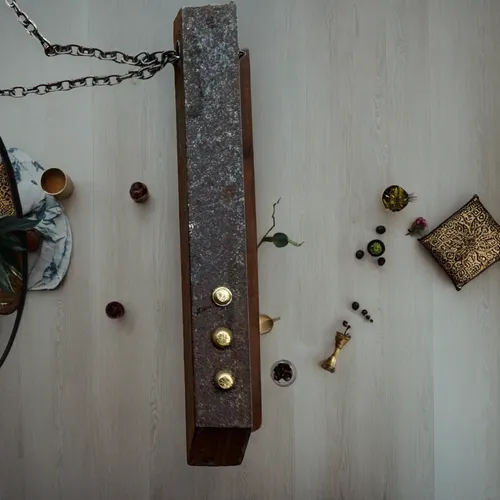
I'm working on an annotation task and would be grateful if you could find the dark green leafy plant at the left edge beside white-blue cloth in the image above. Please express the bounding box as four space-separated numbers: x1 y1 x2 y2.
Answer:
0 215 38 295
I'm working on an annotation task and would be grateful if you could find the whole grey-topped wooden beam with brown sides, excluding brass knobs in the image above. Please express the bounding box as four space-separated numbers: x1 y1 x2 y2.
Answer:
174 3 261 466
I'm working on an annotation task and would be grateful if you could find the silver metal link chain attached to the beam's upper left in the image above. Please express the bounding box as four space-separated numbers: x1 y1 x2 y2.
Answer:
0 0 179 98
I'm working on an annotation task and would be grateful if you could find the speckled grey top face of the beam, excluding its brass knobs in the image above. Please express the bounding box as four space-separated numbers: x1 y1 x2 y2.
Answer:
181 3 252 428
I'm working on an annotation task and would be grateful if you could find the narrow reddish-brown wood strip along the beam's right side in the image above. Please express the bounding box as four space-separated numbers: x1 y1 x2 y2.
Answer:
240 50 262 431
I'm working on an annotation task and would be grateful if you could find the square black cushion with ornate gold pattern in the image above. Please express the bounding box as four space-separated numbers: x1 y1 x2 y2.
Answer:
419 195 500 290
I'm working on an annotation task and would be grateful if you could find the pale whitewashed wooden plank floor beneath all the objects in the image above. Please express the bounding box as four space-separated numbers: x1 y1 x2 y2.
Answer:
0 0 500 500
